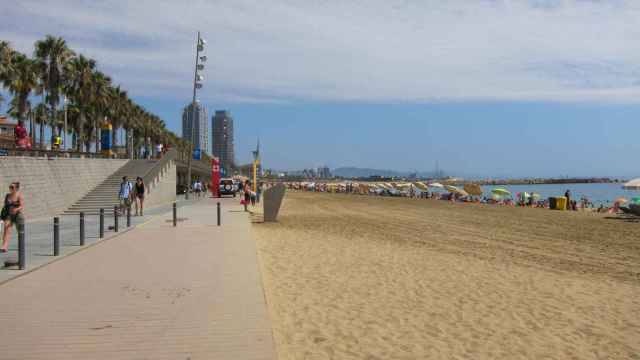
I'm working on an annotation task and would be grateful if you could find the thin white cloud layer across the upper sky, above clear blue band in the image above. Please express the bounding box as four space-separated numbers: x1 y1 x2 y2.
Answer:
0 0 640 102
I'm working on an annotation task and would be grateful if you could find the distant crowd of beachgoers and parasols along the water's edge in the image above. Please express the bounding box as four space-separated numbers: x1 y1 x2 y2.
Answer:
284 182 640 213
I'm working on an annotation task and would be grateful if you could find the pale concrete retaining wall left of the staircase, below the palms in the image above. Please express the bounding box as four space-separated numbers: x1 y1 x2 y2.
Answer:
0 156 127 221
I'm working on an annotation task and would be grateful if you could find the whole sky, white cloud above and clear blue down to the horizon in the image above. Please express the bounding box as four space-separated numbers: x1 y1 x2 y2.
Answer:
0 0 640 177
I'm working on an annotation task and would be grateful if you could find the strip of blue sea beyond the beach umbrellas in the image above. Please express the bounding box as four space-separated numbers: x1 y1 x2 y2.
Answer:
430 183 640 206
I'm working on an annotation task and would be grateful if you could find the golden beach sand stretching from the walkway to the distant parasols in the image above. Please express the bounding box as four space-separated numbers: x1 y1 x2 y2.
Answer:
254 192 640 360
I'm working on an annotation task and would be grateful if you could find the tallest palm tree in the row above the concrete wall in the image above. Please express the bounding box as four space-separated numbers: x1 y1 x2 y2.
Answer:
35 35 74 141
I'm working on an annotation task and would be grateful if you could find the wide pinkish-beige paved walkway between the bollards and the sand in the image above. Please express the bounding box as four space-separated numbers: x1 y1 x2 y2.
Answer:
0 199 275 360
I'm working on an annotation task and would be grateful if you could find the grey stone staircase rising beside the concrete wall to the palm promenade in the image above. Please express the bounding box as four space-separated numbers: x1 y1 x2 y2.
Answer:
64 160 159 215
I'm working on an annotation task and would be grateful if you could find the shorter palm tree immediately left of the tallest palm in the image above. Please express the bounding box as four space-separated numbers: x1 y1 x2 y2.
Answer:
3 52 38 121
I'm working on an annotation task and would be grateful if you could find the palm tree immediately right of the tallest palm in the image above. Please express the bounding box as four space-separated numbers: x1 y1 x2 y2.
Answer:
64 55 96 151
